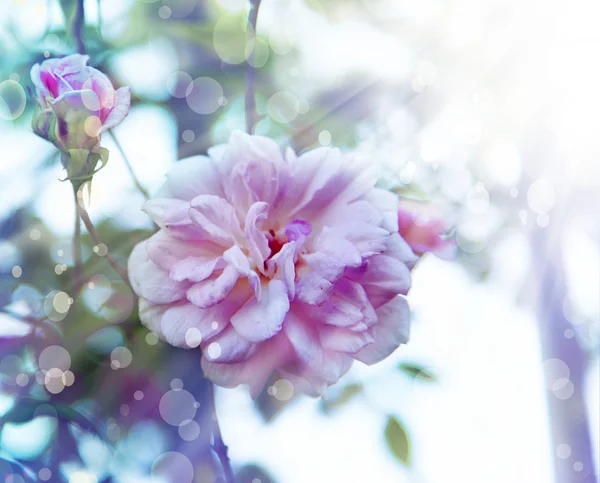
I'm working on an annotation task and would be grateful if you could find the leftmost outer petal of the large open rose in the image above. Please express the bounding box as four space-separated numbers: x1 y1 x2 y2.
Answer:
128 241 190 304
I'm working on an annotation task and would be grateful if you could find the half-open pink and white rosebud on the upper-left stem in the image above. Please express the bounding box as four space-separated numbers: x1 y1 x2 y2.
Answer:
31 54 131 151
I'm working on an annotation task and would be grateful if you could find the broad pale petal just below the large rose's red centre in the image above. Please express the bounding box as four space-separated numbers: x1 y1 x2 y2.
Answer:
231 279 290 342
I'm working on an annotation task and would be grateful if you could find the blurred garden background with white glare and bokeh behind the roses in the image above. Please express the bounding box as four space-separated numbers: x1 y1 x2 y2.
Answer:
0 0 600 483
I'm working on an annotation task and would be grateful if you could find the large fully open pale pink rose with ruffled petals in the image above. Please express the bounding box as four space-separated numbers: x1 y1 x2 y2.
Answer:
129 132 417 396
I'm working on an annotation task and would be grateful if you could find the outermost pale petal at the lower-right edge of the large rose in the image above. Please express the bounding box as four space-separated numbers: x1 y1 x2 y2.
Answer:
354 296 410 365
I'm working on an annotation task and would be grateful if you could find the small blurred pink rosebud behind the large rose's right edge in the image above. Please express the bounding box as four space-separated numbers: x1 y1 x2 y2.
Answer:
398 206 456 258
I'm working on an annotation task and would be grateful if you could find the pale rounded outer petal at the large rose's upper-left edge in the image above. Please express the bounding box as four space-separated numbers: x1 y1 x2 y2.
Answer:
167 156 223 201
